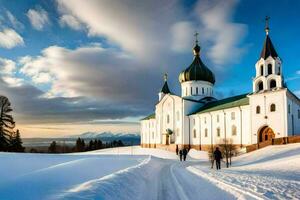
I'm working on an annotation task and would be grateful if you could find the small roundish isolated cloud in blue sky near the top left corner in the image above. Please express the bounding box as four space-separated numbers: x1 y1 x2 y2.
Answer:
26 8 50 31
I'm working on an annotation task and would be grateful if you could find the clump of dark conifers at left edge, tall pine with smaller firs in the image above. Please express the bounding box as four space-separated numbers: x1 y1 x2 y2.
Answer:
0 96 25 152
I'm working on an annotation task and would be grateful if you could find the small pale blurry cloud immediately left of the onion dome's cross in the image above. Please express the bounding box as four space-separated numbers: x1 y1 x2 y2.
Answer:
171 21 196 52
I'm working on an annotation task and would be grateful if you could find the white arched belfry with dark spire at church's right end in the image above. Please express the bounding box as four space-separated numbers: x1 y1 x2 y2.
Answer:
253 16 283 93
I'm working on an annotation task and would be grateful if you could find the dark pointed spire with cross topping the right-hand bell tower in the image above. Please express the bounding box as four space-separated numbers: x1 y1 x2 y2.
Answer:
260 16 278 59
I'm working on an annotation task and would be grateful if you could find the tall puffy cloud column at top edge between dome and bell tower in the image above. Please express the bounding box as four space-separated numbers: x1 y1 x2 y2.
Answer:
195 0 247 65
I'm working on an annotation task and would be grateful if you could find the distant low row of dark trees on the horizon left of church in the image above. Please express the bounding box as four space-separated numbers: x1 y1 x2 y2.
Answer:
47 138 124 153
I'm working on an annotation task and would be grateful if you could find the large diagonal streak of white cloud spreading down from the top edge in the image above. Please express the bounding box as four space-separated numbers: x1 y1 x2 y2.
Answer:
57 0 184 60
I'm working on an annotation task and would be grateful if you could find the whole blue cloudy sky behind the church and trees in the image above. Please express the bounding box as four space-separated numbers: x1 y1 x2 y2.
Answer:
0 0 300 137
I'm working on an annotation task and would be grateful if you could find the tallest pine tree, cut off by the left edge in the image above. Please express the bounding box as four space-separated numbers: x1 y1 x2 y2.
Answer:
0 96 15 151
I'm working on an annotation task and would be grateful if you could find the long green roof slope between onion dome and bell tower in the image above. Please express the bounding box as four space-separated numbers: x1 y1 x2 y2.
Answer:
192 94 249 114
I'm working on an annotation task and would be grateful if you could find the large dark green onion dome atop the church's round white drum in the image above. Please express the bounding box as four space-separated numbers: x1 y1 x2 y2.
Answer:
179 41 216 84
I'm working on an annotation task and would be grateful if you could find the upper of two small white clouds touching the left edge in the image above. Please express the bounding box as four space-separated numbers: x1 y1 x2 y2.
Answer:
0 28 24 49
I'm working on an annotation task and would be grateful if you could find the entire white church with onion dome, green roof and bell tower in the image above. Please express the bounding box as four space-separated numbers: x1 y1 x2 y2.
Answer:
141 21 300 150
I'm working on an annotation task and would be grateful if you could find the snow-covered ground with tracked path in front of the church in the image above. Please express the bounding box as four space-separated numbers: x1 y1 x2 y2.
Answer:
0 144 300 200
